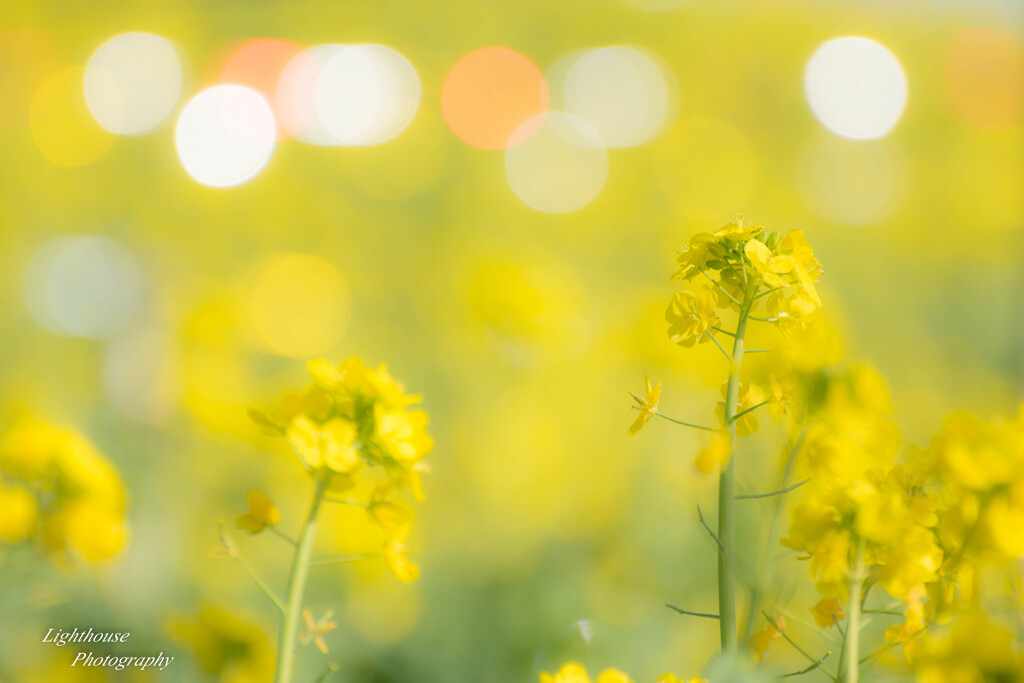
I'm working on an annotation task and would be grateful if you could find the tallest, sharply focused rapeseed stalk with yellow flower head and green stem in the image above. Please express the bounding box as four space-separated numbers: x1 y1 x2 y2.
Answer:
630 216 821 652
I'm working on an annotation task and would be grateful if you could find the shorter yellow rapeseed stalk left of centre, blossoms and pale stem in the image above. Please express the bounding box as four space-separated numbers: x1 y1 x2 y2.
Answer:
218 358 433 683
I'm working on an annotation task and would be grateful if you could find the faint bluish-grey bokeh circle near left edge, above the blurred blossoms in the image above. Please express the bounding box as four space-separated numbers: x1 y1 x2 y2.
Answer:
23 236 142 339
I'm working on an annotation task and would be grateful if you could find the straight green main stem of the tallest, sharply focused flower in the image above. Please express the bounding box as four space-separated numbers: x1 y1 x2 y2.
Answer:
718 286 752 652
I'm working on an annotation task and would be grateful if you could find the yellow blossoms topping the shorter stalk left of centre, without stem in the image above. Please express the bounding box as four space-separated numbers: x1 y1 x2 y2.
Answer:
247 357 433 583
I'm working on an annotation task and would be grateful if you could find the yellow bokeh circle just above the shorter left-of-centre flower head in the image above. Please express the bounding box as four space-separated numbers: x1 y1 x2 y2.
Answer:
252 254 351 358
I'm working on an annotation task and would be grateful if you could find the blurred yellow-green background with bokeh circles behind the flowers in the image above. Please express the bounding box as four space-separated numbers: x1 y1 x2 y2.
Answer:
0 0 1024 683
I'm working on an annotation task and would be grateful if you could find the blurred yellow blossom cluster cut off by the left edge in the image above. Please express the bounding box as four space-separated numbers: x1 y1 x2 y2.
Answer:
0 418 128 565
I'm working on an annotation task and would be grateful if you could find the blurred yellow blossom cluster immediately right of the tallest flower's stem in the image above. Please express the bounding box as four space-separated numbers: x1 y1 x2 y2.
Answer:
782 366 943 655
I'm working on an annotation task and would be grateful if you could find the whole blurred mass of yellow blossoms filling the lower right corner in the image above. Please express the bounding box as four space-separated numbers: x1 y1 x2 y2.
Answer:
774 368 1024 683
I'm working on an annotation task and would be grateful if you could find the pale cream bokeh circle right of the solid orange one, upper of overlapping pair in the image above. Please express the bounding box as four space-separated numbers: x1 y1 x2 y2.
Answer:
548 45 674 147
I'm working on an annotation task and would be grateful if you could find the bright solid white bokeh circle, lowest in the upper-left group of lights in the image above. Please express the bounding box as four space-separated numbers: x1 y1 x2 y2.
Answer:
175 85 276 187
